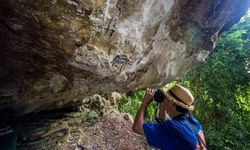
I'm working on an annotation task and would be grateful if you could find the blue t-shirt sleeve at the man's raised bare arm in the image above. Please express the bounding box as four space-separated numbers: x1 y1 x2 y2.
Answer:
143 123 163 148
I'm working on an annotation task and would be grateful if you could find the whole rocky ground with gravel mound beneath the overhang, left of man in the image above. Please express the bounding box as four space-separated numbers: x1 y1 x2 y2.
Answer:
15 95 147 150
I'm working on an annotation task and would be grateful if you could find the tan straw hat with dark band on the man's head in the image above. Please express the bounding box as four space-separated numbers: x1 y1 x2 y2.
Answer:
161 84 194 110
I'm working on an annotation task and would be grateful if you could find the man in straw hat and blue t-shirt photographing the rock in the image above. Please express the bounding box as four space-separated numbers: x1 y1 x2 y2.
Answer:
132 85 206 150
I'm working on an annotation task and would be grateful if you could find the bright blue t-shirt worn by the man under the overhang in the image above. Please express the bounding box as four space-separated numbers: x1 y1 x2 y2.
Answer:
143 115 202 150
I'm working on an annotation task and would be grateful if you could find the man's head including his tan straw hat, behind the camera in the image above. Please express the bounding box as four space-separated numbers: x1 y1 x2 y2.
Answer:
161 85 194 113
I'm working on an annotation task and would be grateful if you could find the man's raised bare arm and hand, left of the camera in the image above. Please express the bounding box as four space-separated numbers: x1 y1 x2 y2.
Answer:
132 89 156 135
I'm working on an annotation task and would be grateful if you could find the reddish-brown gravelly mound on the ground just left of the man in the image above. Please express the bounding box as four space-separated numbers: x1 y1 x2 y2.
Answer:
57 112 146 150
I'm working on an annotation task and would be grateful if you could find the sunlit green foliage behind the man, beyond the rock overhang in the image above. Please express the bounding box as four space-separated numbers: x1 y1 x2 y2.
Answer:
120 14 250 150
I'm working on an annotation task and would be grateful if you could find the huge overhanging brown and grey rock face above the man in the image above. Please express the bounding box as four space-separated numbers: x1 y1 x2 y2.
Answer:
0 0 249 115
